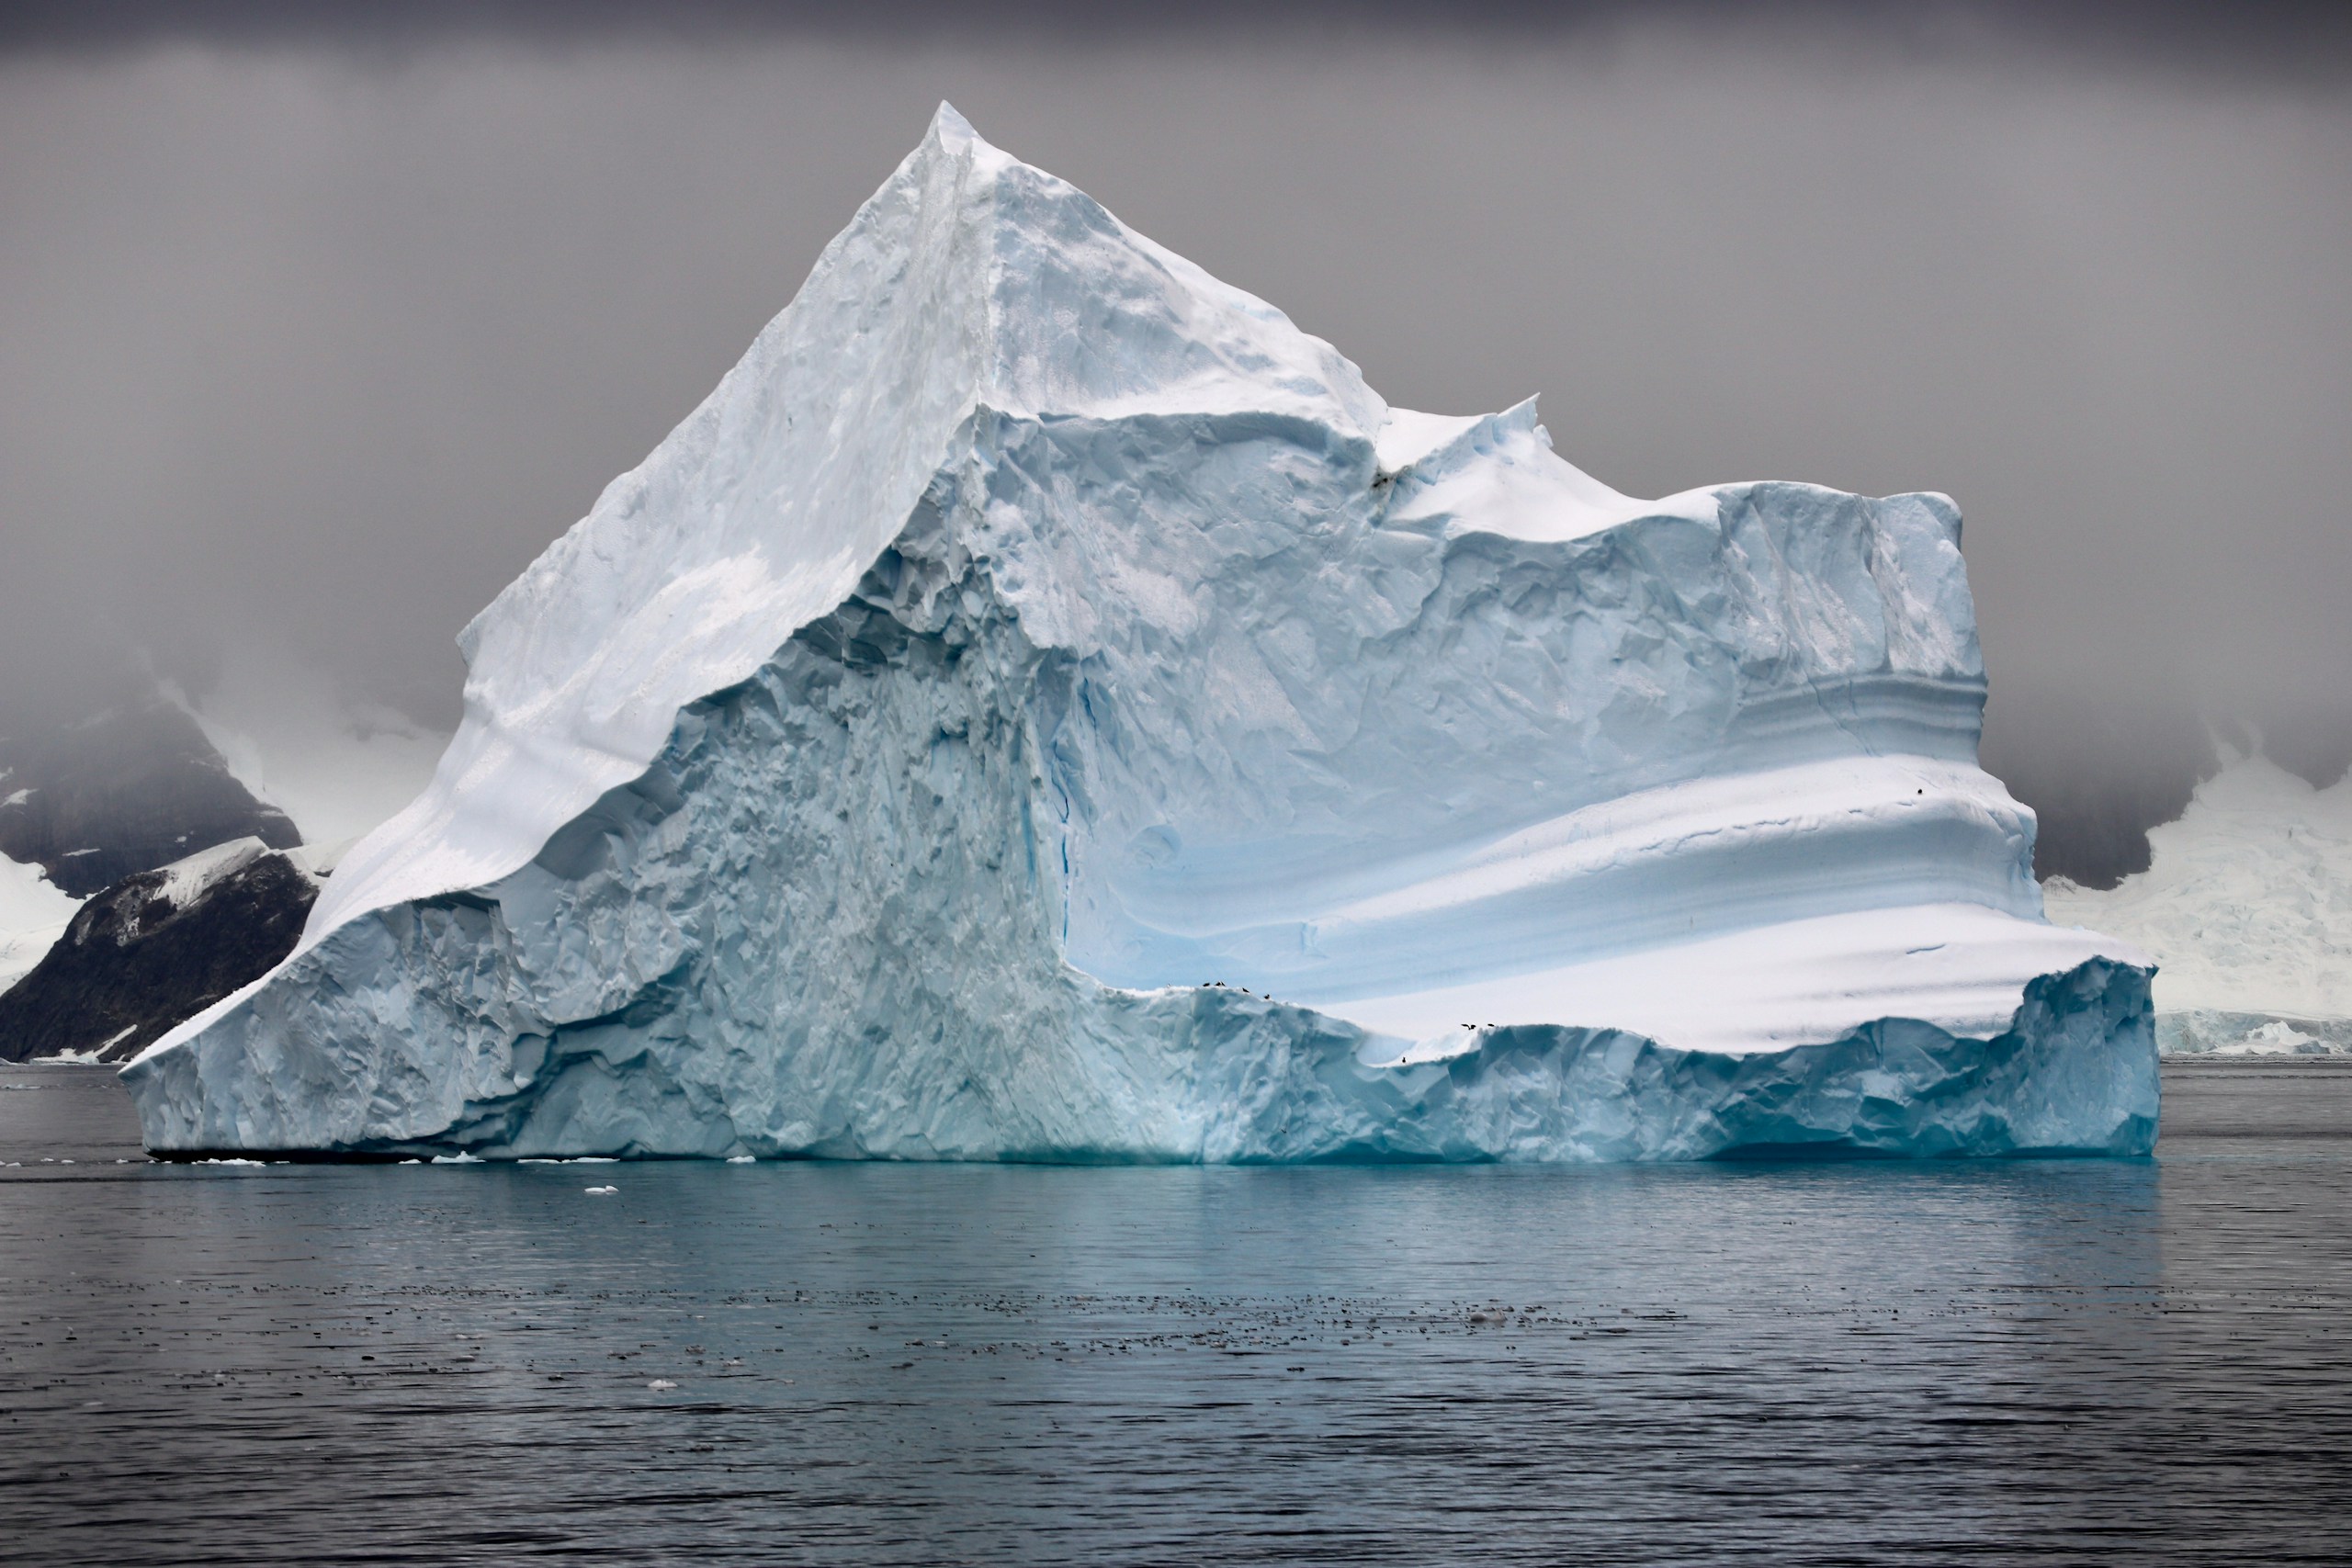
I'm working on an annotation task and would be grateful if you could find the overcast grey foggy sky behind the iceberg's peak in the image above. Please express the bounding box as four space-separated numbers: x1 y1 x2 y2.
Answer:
0 5 2352 879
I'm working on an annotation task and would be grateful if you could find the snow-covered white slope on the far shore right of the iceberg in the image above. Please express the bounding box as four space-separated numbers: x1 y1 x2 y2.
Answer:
2044 752 2352 1055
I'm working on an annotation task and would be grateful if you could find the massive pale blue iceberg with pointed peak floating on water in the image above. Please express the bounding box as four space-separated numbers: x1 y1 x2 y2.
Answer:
122 106 2157 1161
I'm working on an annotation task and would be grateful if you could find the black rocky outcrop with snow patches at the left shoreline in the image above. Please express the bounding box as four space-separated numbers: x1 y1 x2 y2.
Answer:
0 837 320 1063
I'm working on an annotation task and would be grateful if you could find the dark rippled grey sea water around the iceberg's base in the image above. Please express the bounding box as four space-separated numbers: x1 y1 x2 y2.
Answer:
0 1063 2352 1565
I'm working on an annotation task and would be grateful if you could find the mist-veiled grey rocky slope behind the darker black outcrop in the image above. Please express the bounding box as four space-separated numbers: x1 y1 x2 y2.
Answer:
0 694 301 898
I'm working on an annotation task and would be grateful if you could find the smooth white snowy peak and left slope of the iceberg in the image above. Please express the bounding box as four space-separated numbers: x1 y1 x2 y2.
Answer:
306 104 1383 959
